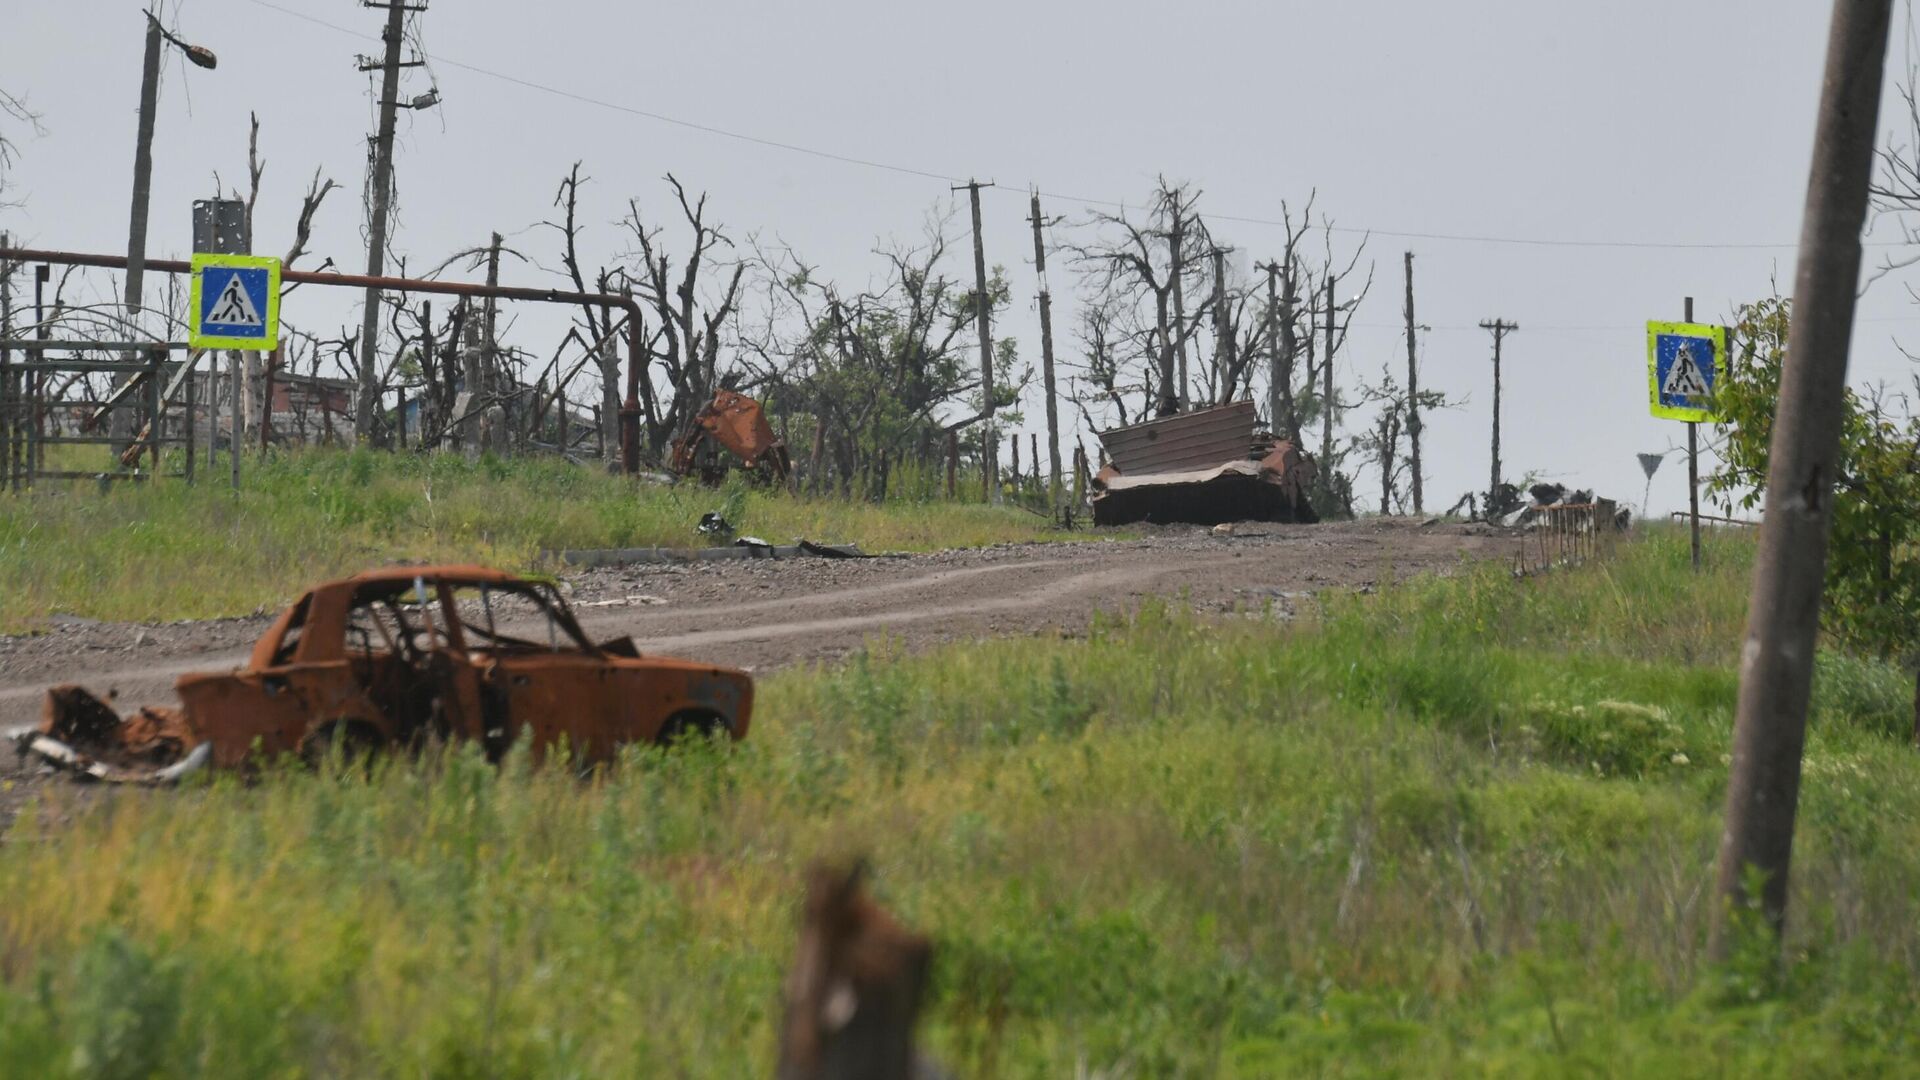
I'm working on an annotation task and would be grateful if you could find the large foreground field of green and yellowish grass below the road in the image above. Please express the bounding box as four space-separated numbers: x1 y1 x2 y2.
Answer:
0 532 1920 1078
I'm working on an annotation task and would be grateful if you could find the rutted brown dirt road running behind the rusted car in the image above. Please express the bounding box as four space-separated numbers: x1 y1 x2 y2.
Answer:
0 521 1513 726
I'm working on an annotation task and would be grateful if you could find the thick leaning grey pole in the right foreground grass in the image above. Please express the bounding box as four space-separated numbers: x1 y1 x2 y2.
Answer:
1711 0 1893 957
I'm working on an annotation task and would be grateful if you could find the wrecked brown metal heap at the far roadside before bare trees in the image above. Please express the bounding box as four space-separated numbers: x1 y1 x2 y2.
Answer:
1092 402 1319 525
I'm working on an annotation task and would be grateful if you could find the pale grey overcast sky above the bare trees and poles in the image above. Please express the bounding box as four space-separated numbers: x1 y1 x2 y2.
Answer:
0 0 1920 513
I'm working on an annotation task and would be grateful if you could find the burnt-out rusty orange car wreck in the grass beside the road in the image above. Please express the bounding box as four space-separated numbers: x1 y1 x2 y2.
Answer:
13 567 753 782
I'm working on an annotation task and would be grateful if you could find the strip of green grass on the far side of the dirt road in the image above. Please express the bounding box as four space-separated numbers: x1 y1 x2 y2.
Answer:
0 452 1068 632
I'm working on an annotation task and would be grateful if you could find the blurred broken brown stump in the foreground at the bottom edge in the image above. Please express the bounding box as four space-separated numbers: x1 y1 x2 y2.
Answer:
776 863 943 1080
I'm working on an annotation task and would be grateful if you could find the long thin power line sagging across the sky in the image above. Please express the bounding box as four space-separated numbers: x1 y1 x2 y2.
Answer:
248 0 1912 252
